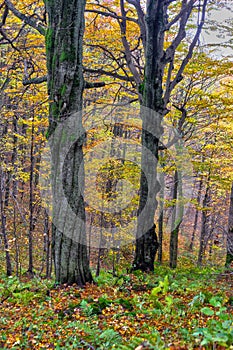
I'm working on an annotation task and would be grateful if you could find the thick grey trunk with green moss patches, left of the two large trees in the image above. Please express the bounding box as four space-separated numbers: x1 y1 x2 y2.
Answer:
46 0 92 286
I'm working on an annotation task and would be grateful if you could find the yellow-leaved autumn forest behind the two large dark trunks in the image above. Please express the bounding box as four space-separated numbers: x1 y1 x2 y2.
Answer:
0 0 233 348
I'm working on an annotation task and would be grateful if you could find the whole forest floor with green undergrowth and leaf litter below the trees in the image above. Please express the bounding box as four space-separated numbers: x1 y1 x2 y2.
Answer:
0 266 233 350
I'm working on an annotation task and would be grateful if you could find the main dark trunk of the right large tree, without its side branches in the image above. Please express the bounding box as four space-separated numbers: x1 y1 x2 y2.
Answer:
133 0 166 271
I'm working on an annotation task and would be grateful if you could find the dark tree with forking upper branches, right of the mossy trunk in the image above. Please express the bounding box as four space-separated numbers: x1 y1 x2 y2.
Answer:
132 0 208 271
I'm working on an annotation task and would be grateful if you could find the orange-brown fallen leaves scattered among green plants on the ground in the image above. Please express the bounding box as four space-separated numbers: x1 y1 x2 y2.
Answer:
0 273 233 350
